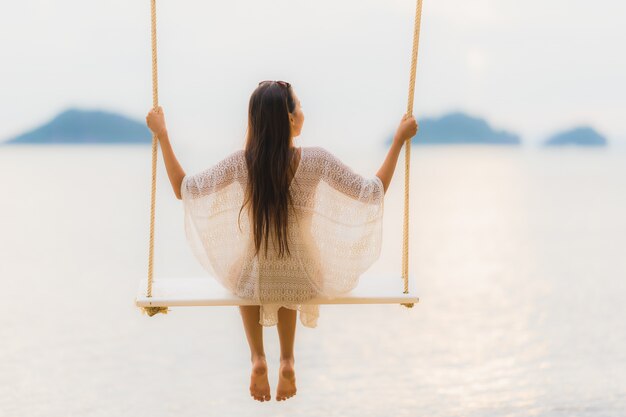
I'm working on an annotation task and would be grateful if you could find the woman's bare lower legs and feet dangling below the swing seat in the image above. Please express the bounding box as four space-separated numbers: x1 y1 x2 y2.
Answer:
239 306 297 401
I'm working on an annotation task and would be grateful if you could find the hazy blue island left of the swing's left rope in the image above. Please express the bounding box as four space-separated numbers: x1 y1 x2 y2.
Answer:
4 109 152 145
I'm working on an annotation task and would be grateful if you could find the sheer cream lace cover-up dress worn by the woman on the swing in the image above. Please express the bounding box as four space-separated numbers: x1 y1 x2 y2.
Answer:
181 146 384 327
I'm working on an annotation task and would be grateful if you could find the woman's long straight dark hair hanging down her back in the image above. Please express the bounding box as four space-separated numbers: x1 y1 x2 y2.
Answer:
239 82 296 258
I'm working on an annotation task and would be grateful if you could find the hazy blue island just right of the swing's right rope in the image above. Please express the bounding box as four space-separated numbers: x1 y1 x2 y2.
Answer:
388 112 521 145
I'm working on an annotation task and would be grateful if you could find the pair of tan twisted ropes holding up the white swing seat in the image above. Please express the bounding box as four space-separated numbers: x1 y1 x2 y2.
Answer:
142 0 422 316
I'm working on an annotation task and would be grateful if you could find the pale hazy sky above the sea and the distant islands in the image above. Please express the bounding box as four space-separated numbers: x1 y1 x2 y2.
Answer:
0 0 626 149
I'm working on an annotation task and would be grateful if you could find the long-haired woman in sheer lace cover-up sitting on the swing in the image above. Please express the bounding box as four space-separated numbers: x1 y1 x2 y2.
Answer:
146 81 417 401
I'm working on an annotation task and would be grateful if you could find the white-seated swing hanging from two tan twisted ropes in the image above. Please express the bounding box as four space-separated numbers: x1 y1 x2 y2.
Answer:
135 0 422 316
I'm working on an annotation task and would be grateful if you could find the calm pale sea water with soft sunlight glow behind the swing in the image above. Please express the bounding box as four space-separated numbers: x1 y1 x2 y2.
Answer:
0 147 626 417
